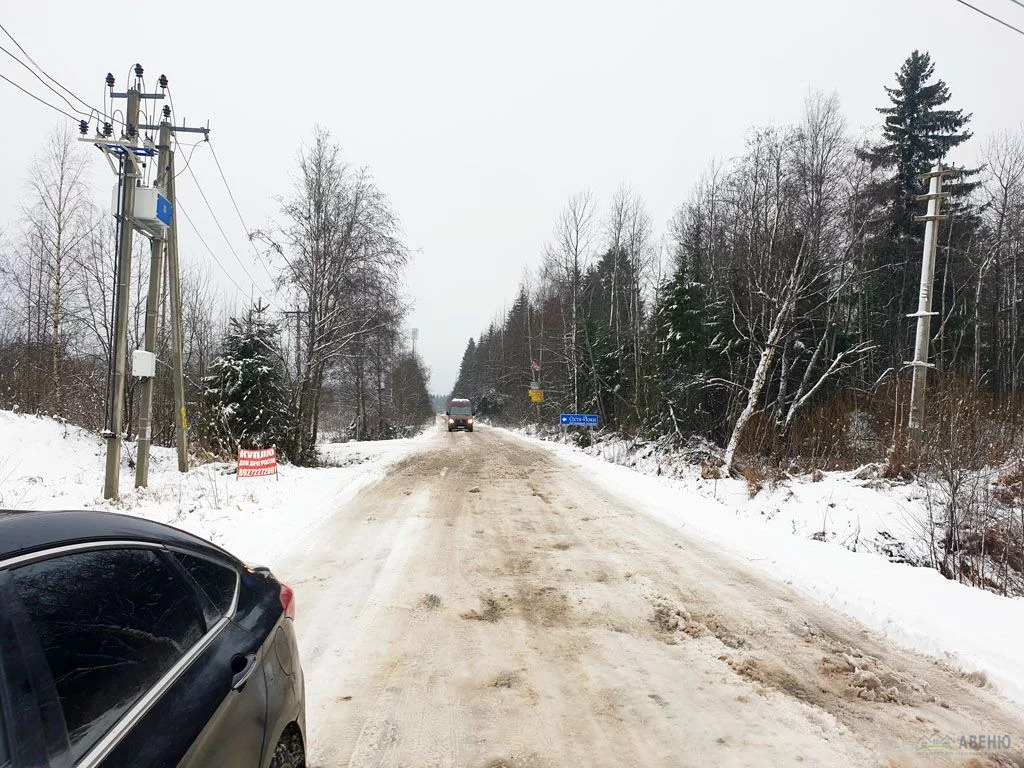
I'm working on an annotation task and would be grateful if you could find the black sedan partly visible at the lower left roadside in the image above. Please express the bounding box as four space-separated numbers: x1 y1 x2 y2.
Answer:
0 511 305 768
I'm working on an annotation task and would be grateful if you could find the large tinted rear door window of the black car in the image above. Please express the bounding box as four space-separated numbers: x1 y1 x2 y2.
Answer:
11 549 206 761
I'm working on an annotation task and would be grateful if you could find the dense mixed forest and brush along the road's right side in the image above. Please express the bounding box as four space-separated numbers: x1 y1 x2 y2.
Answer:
454 51 1024 591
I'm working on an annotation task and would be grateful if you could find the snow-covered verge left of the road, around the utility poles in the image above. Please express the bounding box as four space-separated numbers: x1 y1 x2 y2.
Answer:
0 411 428 565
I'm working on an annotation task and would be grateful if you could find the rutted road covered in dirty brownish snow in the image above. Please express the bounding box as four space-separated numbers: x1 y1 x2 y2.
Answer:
275 429 1024 768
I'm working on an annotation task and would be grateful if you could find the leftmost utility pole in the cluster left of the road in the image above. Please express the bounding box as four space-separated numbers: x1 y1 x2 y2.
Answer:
103 88 141 499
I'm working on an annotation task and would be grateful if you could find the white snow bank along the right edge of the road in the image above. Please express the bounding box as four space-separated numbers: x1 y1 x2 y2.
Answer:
509 428 1024 703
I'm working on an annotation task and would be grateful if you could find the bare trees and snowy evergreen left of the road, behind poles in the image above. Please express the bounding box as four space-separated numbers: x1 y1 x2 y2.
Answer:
0 127 433 464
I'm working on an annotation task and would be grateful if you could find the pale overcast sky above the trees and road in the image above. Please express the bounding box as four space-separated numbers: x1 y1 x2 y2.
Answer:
0 0 1024 392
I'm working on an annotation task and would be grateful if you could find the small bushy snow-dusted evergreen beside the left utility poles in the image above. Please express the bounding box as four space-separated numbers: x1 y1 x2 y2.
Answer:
203 307 294 461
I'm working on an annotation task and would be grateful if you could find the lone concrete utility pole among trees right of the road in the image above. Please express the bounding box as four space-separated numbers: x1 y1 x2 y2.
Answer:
907 165 956 458
